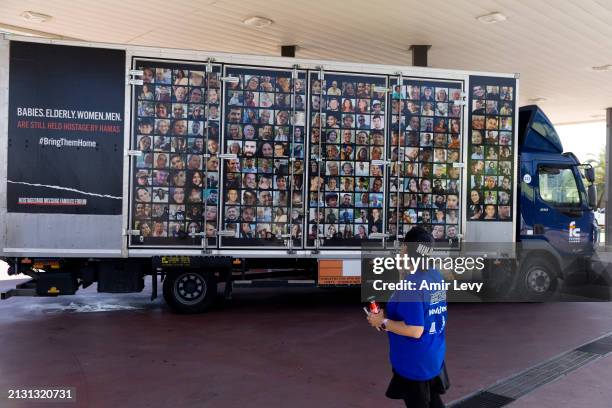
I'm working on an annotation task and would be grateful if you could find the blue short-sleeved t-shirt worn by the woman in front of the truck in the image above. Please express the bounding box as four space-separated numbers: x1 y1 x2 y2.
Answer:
386 269 447 381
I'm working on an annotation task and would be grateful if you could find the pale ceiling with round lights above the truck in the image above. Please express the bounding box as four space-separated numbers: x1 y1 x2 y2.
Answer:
0 0 612 123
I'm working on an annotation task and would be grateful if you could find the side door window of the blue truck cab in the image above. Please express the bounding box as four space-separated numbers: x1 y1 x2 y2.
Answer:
538 165 580 207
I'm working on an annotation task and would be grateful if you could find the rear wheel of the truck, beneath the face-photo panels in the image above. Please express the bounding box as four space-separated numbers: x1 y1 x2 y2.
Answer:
164 270 217 314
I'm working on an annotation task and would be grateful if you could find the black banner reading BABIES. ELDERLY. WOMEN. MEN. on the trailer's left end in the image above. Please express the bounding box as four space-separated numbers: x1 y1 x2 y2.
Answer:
7 42 125 214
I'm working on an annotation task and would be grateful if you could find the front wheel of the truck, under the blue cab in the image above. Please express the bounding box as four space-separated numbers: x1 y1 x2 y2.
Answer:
517 259 558 302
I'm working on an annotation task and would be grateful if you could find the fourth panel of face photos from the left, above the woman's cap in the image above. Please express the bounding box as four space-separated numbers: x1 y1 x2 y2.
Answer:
387 80 462 240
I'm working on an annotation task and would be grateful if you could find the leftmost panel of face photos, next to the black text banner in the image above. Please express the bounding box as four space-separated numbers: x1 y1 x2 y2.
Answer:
132 61 221 246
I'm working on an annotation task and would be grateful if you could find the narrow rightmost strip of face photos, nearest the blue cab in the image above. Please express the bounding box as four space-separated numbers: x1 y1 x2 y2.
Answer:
468 77 516 221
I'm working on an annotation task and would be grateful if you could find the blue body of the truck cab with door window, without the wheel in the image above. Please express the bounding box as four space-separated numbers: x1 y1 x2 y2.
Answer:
518 105 596 267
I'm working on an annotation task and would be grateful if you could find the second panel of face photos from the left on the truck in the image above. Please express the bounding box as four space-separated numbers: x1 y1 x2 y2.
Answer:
221 67 306 247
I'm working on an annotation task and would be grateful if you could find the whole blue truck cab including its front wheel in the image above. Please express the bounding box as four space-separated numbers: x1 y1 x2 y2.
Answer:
517 105 598 297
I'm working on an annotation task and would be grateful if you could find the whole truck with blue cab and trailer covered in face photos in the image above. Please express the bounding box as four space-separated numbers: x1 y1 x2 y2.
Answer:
0 35 598 313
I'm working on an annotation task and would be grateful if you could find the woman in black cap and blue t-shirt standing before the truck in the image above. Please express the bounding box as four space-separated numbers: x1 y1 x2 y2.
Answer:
367 226 448 408
